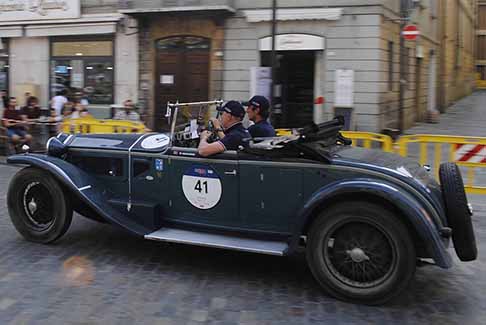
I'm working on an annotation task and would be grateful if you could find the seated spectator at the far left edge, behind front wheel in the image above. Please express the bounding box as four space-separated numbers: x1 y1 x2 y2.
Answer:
2 97 32 145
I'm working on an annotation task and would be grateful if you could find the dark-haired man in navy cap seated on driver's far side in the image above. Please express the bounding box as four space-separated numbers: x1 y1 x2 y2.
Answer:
243 96 275 138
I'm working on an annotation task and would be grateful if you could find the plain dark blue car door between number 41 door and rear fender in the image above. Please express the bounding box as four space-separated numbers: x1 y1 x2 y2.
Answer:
239 159 303 233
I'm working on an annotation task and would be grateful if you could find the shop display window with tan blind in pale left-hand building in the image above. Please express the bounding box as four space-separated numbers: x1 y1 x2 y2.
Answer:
50 40 114 104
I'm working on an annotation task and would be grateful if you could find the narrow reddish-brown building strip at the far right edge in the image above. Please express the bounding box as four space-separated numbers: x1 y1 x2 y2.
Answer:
476 0 486 89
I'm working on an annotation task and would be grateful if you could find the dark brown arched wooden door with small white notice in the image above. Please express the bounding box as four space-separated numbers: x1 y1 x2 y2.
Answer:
155 36 210 130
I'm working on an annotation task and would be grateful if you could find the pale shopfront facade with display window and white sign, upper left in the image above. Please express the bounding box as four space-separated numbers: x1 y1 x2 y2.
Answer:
0 0 138 117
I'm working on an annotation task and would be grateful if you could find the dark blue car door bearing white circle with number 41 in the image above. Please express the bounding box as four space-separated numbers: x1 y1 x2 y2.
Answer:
169 148 242 227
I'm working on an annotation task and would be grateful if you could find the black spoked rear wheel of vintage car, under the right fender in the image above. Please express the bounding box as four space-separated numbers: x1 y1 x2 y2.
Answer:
307 201 416 305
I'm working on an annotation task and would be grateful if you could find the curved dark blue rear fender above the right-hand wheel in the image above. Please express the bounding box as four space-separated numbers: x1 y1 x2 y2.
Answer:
289 179 452 268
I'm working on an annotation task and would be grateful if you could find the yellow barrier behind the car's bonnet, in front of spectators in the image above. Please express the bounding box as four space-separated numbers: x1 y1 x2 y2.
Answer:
61 117 145 133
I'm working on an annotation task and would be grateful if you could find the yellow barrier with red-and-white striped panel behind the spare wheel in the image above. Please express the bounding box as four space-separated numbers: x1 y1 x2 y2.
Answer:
396 134 486 195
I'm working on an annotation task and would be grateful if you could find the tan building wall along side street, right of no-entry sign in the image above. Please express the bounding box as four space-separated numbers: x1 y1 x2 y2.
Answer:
439 0 476 112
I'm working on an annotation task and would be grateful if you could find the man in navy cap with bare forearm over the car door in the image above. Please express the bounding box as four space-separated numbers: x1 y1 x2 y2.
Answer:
198 100 251 157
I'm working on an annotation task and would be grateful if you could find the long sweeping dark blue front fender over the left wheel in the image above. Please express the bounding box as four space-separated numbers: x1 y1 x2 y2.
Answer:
7 154 149 236
